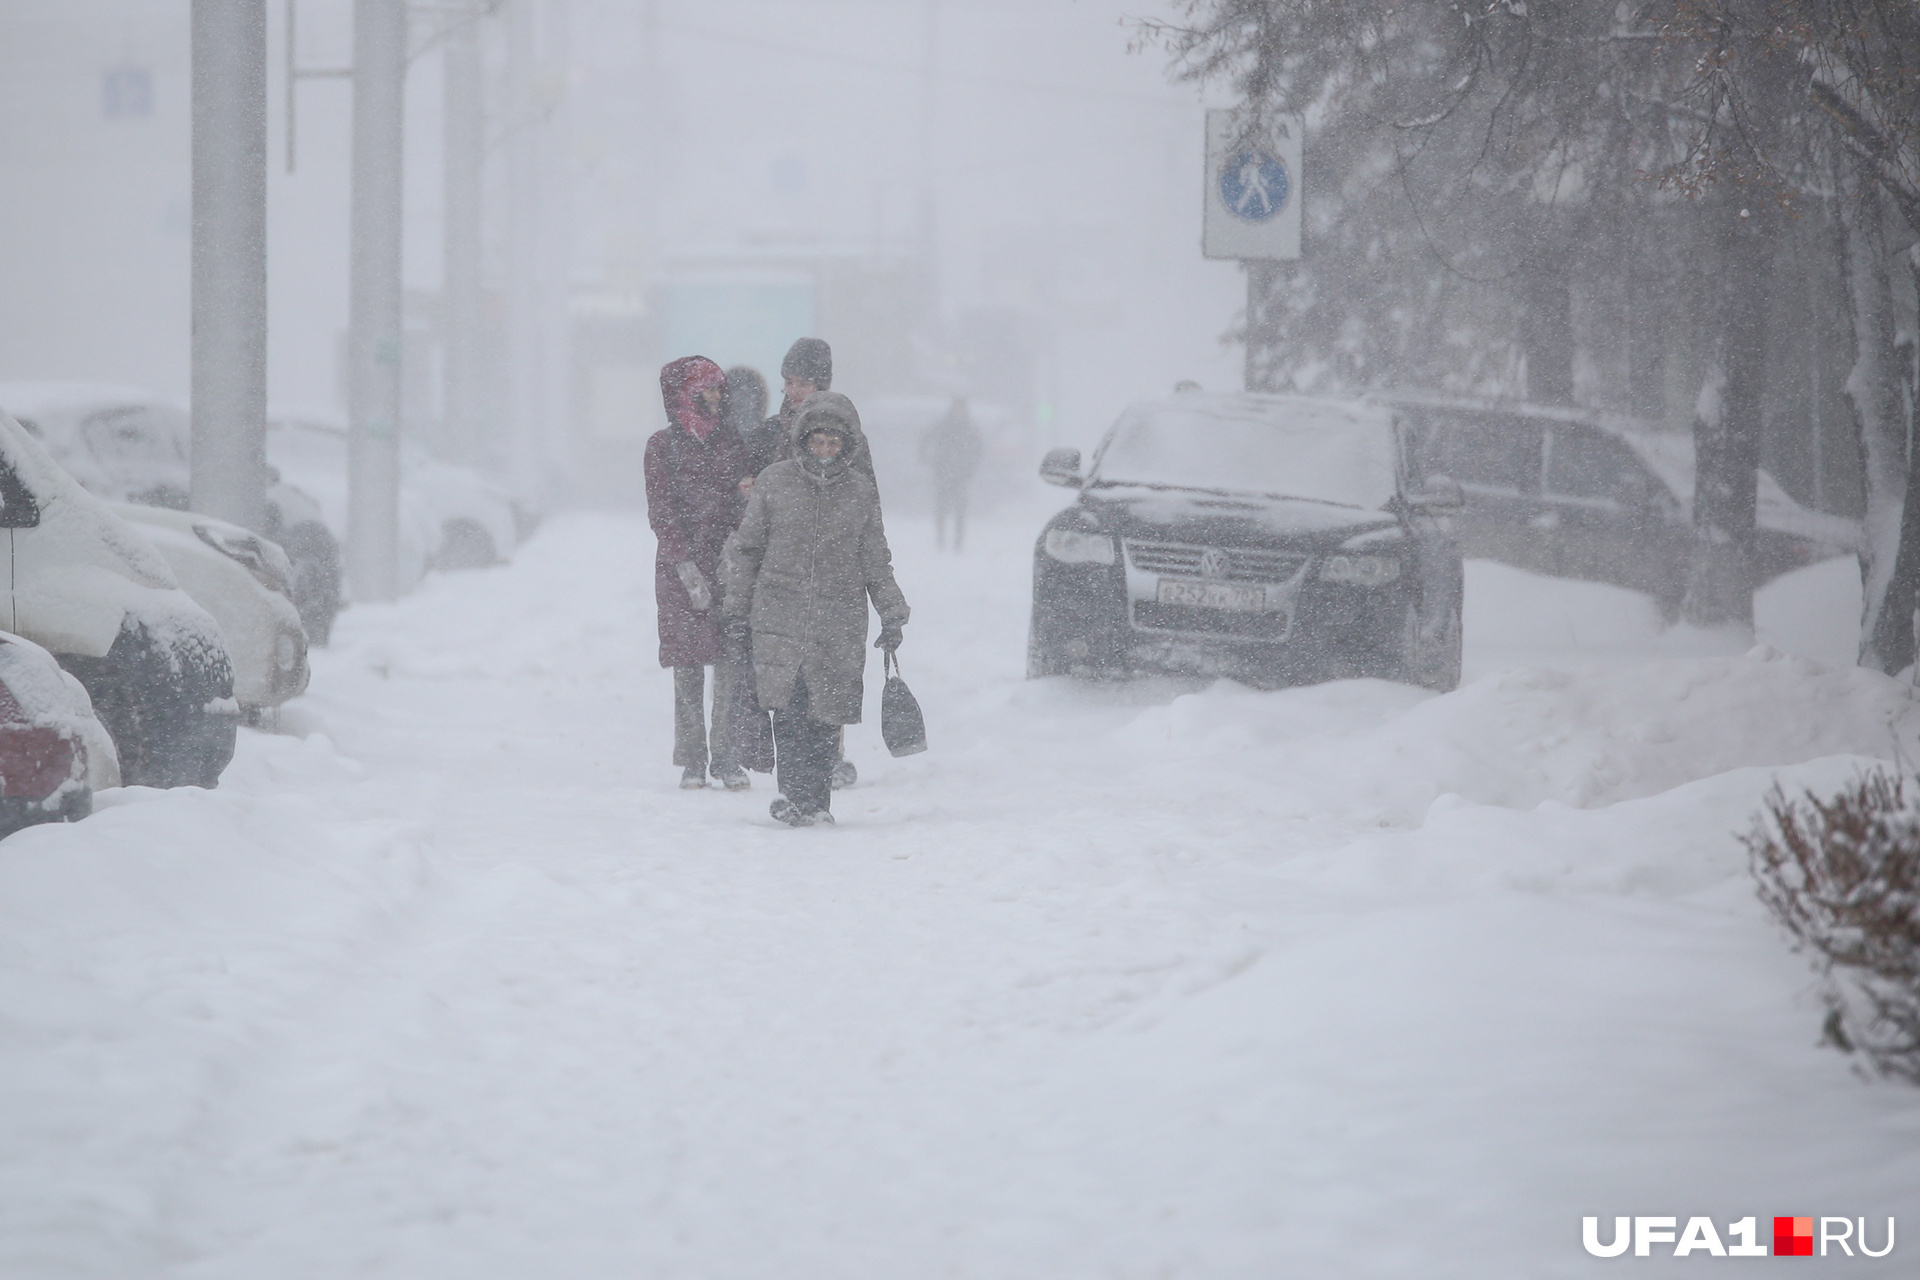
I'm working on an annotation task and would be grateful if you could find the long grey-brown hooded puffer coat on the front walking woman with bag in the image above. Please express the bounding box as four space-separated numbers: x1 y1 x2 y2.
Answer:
720 391 910 723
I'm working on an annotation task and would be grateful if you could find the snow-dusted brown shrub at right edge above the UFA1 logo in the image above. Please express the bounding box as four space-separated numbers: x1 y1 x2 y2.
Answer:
1747 771 1920 1084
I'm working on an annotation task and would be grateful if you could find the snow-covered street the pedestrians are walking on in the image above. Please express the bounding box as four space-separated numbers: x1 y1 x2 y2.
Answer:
0 499 1920 1280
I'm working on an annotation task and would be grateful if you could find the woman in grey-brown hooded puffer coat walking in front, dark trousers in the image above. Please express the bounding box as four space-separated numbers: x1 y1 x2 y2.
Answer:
720 391 910 827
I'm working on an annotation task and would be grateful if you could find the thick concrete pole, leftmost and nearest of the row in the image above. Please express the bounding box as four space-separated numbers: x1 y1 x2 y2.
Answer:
190 0 267 530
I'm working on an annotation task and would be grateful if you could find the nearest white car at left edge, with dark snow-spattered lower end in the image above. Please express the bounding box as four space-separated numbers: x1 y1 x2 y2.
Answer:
0 413 238 787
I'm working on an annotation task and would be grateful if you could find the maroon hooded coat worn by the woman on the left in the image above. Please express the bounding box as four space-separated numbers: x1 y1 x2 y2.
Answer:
647 355 747 666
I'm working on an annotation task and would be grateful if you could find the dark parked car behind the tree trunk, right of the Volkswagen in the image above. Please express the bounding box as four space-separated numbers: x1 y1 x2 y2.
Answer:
1394 395 1860 614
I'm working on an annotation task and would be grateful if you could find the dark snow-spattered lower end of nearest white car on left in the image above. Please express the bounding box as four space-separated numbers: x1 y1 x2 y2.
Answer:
60 629 238 789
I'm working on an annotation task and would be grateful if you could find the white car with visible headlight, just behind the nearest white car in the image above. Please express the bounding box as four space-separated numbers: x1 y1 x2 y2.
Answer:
113 503 309 722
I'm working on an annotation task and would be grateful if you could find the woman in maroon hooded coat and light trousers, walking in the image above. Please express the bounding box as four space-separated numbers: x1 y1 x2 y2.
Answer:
647 355 751 791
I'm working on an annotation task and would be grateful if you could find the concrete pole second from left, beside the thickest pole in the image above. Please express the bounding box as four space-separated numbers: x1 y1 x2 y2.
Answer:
348 0 407 601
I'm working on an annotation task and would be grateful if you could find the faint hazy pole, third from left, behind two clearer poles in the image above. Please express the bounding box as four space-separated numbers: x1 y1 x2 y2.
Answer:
442 6 486 462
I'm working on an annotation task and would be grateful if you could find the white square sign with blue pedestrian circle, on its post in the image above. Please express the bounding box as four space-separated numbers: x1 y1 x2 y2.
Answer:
1200 111 1304 391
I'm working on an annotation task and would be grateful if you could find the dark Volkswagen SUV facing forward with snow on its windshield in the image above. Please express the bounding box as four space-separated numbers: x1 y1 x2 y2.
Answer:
1027 393 1461 689
